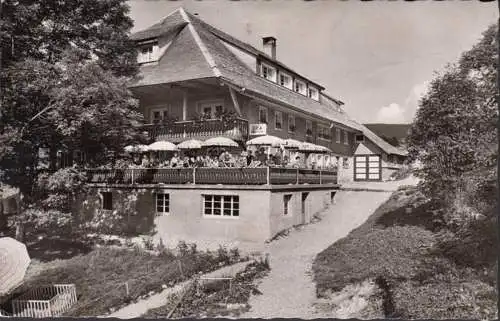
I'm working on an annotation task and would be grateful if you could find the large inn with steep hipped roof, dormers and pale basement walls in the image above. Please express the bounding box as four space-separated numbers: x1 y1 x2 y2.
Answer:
82 8 404 241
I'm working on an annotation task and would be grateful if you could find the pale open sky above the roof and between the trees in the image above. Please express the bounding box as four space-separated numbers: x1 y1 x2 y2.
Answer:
129 0 498 123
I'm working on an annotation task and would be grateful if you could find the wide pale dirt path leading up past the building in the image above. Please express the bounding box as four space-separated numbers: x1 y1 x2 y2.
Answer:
241 191 391 319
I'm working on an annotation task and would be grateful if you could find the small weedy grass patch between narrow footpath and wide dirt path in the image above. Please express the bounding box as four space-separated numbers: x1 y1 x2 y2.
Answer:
144 261 269 318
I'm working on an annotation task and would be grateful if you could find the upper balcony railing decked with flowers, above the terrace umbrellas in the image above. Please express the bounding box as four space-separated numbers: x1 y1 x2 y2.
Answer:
144 118 248 141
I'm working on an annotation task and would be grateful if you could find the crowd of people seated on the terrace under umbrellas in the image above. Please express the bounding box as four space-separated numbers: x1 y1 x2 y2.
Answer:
132 148 304 168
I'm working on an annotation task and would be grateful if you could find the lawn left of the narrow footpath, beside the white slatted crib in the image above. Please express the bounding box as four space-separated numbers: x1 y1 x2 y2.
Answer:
4 242 243 316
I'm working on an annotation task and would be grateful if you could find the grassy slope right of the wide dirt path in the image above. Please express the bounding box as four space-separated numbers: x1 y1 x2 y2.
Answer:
313 187 497 319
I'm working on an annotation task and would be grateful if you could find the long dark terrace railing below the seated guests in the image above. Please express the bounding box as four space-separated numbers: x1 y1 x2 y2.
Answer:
87 167 337 185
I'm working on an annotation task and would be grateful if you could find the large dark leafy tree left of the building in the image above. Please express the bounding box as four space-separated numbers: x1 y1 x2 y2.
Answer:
0 0 145 235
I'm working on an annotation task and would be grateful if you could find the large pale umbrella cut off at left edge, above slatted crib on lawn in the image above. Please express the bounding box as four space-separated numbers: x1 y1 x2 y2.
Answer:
0 237 30 295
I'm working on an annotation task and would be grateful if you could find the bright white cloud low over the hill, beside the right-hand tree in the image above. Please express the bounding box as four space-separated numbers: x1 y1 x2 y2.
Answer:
375 81 429 124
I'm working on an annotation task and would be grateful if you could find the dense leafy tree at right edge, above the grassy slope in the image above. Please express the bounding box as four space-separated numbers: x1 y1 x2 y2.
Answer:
409 25 498 210
